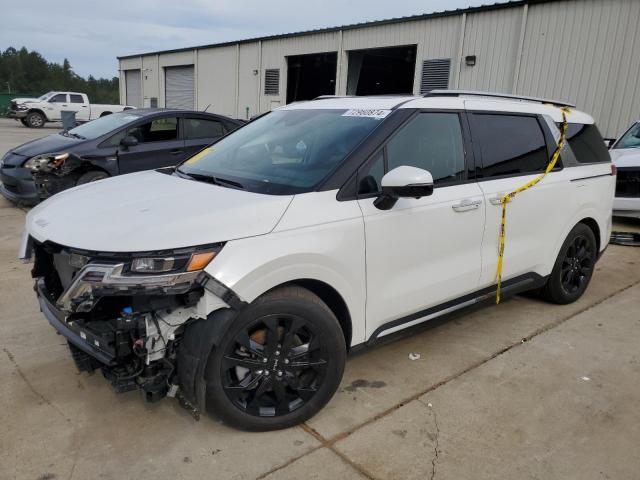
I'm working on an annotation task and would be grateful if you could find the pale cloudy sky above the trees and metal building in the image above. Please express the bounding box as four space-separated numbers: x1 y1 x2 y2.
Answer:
0 0 490 77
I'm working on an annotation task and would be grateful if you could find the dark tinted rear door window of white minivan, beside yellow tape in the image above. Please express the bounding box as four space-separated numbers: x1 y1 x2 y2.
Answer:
470 114 549 177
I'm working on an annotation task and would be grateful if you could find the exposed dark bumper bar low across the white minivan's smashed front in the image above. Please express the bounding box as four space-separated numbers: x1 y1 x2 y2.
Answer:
35 278 116 366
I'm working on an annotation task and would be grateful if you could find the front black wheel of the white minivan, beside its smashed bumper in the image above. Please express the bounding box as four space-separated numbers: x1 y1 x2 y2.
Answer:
205 286 346 431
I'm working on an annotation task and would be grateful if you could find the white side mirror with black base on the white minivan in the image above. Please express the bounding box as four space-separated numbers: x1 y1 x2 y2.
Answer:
373 166 433 210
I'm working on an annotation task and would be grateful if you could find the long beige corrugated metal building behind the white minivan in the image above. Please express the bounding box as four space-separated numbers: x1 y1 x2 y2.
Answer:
119 0 640 137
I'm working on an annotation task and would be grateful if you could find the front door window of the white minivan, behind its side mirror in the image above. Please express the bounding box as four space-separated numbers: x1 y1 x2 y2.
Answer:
358 113 465 195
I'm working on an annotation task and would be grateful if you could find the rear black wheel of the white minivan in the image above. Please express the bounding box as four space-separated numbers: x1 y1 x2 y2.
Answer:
540 223 598 305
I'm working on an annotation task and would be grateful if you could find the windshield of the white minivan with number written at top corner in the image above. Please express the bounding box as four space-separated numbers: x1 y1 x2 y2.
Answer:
178 109 389 195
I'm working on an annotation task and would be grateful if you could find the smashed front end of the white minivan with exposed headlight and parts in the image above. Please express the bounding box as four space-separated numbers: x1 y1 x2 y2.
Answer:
26 238 228 402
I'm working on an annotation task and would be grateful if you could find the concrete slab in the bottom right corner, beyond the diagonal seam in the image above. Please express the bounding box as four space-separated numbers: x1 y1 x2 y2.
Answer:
335 286 640 480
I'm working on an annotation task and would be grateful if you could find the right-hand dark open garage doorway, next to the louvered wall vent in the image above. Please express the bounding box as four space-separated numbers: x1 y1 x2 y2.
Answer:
347 45 417 95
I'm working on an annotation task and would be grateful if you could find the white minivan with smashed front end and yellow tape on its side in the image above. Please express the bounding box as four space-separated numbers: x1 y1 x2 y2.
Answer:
21 91 615 430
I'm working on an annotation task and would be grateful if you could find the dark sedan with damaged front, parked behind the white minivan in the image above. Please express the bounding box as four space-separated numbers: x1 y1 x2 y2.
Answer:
0 109 243 205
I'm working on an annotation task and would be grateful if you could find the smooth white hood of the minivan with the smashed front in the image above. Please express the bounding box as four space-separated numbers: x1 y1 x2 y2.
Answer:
26 171 293 252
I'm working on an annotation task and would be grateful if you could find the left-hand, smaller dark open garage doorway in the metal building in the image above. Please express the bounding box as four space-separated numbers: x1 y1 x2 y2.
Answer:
287 52 338 103
